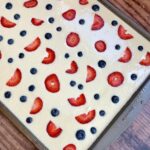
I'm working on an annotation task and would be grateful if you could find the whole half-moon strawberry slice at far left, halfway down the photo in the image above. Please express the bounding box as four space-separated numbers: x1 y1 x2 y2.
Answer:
6 68 22 86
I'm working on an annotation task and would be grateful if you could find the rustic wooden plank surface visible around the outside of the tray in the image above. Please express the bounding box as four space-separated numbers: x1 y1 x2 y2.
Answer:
0 0 150 150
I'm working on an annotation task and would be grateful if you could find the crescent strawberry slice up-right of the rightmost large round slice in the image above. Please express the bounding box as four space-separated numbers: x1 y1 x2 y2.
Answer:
118 47 132 63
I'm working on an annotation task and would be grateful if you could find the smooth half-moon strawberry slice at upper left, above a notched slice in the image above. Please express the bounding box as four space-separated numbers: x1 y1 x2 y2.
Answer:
24 37 41 52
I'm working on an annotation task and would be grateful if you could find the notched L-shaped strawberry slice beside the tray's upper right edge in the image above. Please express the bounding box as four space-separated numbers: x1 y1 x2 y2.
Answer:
118 25 133 40
